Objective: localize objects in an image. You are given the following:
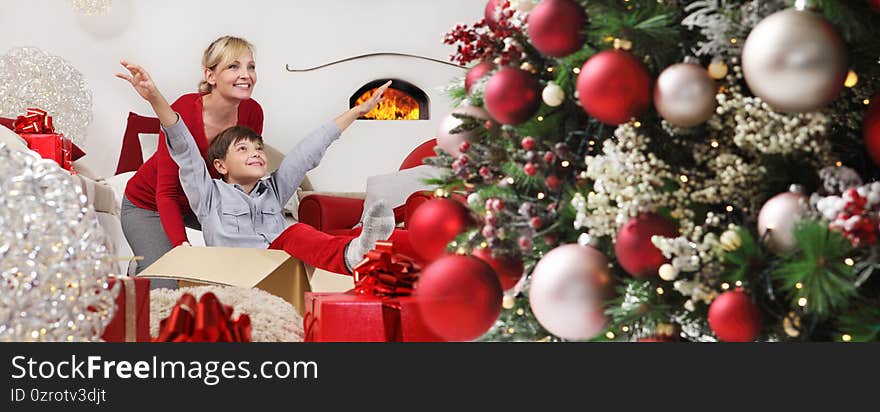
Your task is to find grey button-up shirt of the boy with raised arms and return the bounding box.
[162,116,342,248]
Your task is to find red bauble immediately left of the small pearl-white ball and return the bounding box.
[483,67,541,124]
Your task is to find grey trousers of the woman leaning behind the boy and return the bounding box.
[120,197,202,289]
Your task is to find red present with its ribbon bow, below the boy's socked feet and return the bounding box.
[303,242,444,342]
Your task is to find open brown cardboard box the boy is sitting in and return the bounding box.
[138,246,311,314]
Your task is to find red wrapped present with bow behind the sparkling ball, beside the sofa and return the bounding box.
[13,108,85,171]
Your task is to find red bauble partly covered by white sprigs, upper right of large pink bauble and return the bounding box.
[614,213,679,279]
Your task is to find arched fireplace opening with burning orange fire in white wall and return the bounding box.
[348,79,431,120]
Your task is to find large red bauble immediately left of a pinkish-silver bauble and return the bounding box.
[576,50,651,125]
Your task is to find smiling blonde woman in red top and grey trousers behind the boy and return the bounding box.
[121,36,263,288]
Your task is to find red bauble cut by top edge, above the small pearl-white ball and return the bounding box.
[528,0,586,57]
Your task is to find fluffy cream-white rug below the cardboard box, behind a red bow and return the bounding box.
[150,286,303,342]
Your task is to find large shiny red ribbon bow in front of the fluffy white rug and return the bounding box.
[153,292,251,342]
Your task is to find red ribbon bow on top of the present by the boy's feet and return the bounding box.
[354,241,421,297]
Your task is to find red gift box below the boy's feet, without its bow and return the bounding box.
[303,291,445,342]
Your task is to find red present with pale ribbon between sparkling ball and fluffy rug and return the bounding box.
[101,276,150,342]
